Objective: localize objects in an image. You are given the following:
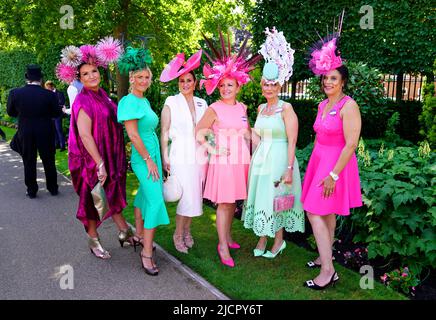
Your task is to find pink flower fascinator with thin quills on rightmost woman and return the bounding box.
[309,11,344,75]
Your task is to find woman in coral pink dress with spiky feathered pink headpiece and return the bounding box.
[196,34,261,267]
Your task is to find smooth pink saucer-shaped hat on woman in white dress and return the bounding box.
[159,49,203,82]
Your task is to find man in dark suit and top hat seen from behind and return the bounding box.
[7,65,62,199]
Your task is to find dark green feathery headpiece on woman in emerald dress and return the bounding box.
[117,46,153,75]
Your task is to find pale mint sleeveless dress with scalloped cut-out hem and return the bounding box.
[242,100,304,238]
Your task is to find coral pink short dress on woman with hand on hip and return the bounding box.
[203,101,250,203]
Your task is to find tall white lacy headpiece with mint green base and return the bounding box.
[259,27,295,86]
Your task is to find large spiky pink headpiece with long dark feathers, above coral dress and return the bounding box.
[200,31,262,95]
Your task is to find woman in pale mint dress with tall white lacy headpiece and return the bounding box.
[242,29,304,258]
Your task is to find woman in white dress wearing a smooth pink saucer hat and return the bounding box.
[160,50,207,253]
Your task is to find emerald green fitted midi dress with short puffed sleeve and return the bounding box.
[117,93,170,229]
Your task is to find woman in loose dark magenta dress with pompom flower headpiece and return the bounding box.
[57,38,133,259]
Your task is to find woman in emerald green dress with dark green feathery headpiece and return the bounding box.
[118,47,170,276]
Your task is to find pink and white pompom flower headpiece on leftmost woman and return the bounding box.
[56,36,123,84]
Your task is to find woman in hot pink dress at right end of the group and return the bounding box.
[301,15,362,290]
